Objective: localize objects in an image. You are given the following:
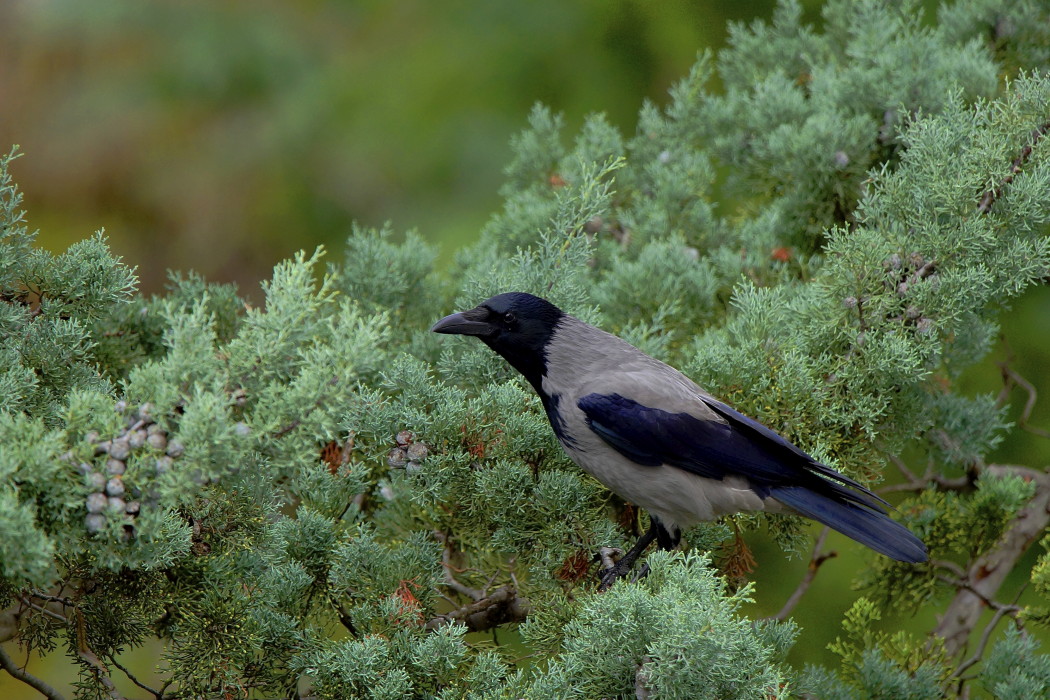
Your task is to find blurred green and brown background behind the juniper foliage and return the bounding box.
[0,0,1050,700]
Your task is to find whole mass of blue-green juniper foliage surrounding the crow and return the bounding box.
[0,0,1050,700]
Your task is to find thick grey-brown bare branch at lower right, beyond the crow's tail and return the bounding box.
[932,465,1050,655]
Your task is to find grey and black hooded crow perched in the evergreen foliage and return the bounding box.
[431,292,928,590]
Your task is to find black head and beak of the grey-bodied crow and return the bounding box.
[431,292,565,393]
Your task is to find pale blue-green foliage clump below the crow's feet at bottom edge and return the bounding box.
[522,552,794,700]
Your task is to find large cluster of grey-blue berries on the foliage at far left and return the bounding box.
[66,401,185,538]
